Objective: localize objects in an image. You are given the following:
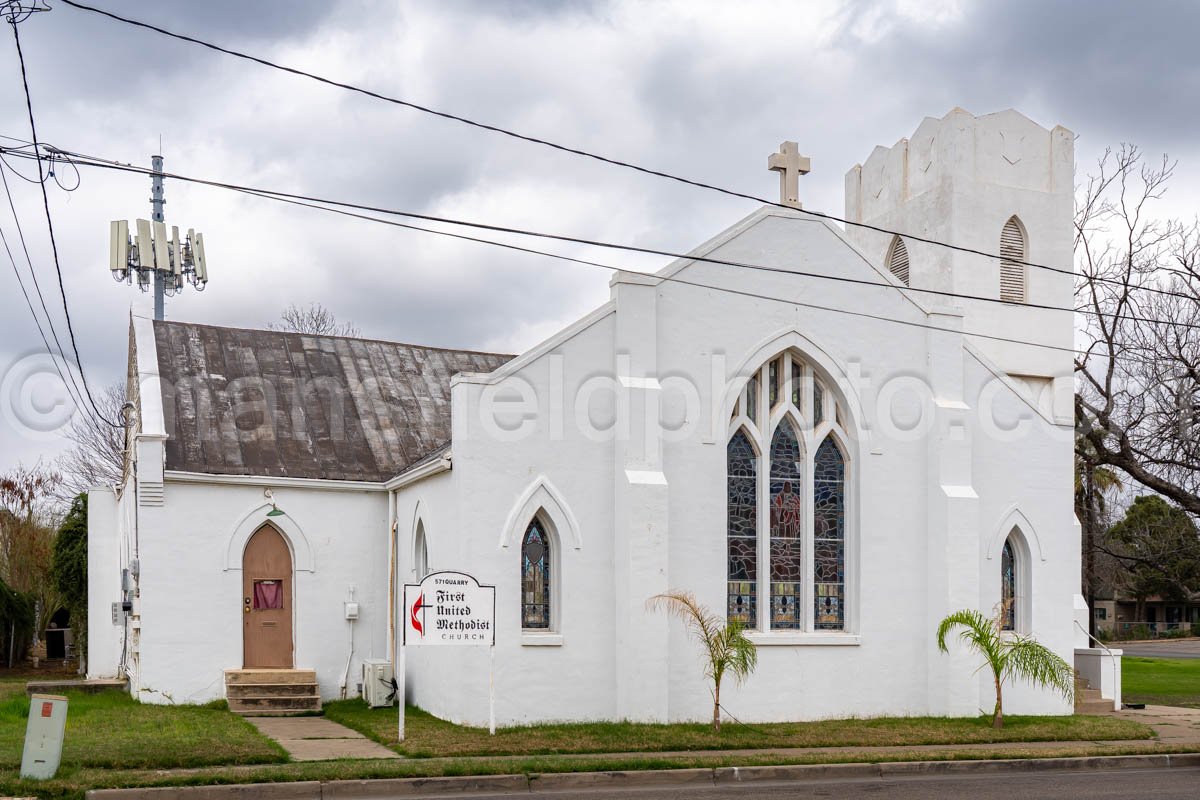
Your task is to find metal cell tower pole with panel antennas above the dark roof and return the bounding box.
[108,155,209,319]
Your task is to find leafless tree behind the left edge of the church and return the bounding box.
[56,383,126,505]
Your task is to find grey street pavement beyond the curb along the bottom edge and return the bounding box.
[391,768,1200,800]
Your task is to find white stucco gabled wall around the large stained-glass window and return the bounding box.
[406,200,1079,724]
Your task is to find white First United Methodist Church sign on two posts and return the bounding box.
[397,571,496,741]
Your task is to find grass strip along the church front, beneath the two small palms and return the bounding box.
[325,700,1152,758]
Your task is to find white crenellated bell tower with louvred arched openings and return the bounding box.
[846,108,1074,419]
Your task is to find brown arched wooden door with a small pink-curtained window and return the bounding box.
[241,525,294,669]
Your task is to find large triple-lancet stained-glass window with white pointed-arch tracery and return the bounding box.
[726,351,850,632]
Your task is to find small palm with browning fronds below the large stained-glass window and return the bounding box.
[646,591,758,733]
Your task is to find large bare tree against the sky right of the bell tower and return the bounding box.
[1075,145,1200,515]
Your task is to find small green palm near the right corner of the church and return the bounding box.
[937,607,1075,728]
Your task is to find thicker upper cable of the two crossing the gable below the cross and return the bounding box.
[11,146,1200,329]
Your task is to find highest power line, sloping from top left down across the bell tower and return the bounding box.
[62,0,1128,291]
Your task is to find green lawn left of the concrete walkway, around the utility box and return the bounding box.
[0,678,287,772]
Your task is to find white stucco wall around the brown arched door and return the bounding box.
[133,474,389,703]
